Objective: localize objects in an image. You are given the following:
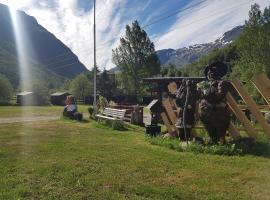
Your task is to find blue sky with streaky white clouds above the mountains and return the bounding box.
[0,0,270,70]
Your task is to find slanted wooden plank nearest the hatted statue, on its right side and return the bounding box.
[226,92,257,138]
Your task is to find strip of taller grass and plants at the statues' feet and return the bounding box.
[146,136,270,158]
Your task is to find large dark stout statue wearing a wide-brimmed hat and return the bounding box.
[198,62,231,143]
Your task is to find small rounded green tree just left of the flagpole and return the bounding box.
[70,74,94,99]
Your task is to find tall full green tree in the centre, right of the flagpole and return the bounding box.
[112,21,160,97]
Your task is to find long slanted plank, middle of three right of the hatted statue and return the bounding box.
[231,80,270,136]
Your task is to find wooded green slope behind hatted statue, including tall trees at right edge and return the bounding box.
[180,4,270,95]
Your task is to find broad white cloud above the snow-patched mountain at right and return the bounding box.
[154,0,270,49]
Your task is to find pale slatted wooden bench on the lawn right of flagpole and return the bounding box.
[96,108,126,121]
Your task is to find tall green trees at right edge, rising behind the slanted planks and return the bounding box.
[231,4,270,98]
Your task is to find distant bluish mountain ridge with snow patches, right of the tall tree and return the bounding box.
[157,26,244,68]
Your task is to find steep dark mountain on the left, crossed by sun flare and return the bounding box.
[0,4,87,85]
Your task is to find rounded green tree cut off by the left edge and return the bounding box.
[0,74,13,104]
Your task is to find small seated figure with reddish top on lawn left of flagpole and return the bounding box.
[63,95,82,121]
